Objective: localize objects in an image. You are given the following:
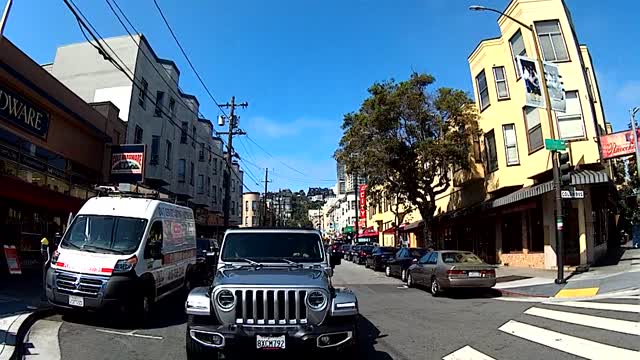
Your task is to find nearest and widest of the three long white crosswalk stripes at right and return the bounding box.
[499,320,640,360]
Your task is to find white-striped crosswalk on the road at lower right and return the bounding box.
[443,296,640,360]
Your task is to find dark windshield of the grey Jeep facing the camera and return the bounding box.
[222,232,324,263]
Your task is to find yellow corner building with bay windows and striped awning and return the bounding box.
[434,0,615,268]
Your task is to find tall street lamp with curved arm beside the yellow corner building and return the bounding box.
[469,5,566,284]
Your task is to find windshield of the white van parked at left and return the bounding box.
[60,215,147,255]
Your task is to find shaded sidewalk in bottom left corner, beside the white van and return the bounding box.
[0,271,49,360]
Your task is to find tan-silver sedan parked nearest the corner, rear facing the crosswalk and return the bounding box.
[407,250,496,296]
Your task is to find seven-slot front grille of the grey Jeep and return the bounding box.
[234,289,308,325]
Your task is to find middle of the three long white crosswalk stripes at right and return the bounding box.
[524,307,640,336]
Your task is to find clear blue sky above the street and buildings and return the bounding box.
[1,0,640,190]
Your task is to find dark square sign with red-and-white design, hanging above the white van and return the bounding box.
[111,144,146,183]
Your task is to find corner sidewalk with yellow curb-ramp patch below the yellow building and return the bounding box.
[495,249,640,298]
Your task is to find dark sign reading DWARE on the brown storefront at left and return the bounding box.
[0,87,49,139]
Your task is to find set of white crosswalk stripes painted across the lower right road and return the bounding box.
[443,297,640,360]
